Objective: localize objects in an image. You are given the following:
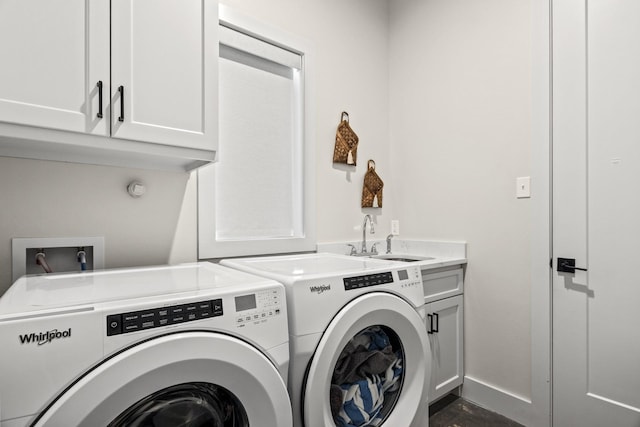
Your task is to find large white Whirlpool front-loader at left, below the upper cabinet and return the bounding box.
[0,263,292,427]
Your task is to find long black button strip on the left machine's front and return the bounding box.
[107,298,223,336]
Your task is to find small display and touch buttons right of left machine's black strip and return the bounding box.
[234,289,283,327]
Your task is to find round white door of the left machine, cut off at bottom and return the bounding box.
[33,332,293,427]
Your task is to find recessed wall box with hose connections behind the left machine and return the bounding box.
[11,237,104,282]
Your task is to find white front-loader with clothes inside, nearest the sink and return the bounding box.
[221,254,431,427]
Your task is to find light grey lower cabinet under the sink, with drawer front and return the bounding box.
[422,268,464,403]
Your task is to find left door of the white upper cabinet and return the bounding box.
[0,0,109,135]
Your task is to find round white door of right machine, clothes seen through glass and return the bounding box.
[303,292,431,427]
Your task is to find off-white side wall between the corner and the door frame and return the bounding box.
[390,0,535,412]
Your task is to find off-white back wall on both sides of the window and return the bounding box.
[0,0,394,294]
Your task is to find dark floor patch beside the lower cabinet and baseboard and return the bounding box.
[429,394,523,427]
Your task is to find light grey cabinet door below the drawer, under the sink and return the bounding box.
[427,295,464,402]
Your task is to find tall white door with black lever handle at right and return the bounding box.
[553,0,640,427]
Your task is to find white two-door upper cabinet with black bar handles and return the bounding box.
[0,0,218,170]
